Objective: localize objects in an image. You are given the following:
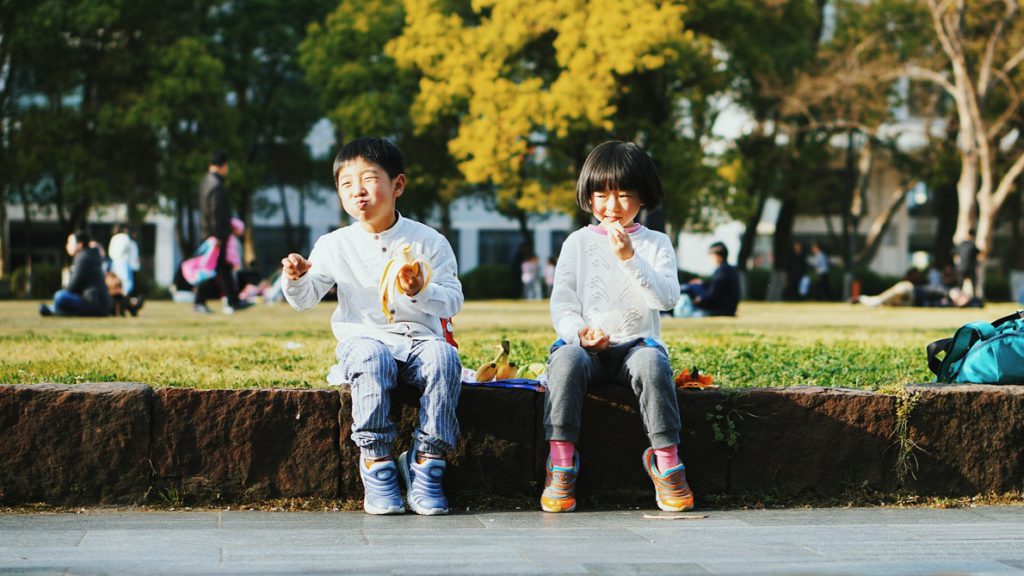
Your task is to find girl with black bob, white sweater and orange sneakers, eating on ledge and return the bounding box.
[541,141,693,512]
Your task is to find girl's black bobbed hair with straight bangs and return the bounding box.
[577,140,665,212]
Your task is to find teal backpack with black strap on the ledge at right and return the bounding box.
[928,310,1024,384]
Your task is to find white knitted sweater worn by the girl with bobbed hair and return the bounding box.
[551,227,679,346]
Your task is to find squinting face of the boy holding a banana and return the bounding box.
[337,158,406,232]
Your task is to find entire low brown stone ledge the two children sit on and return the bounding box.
[0,383,1024,504]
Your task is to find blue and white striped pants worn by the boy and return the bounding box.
[335,338,462,458]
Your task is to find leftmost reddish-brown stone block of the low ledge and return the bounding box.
[0,383,153,505]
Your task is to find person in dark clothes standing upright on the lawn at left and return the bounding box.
[193,152,248,314]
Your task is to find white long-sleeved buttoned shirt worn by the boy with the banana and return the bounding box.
[284,214,463,373]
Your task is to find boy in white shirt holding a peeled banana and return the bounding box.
[282,137,463,516]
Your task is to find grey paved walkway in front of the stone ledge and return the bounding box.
[0,506,1024,576]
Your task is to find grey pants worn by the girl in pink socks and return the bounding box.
[544,340,679,448]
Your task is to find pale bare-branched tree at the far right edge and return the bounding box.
[900,0,1024,290]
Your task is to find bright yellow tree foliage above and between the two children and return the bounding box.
[386,0,690,211]
